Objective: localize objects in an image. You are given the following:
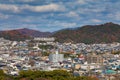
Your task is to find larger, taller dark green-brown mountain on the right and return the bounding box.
[53,22,120,44]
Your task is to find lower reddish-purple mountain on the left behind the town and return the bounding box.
[0,28,52,41]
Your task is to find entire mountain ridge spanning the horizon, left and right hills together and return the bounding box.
[0,22,120,44]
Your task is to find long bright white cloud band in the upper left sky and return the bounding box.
[0,4,65,13]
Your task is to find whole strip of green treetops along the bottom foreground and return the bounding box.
[0,70,97,80]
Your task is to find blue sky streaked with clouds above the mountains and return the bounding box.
[0,0,120,32]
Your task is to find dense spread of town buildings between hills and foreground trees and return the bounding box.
[0,38,120,80]
